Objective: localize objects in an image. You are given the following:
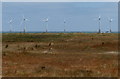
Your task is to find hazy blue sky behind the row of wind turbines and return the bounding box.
[2,2,118,31]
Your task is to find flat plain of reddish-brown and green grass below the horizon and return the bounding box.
[2,33,118,77]
